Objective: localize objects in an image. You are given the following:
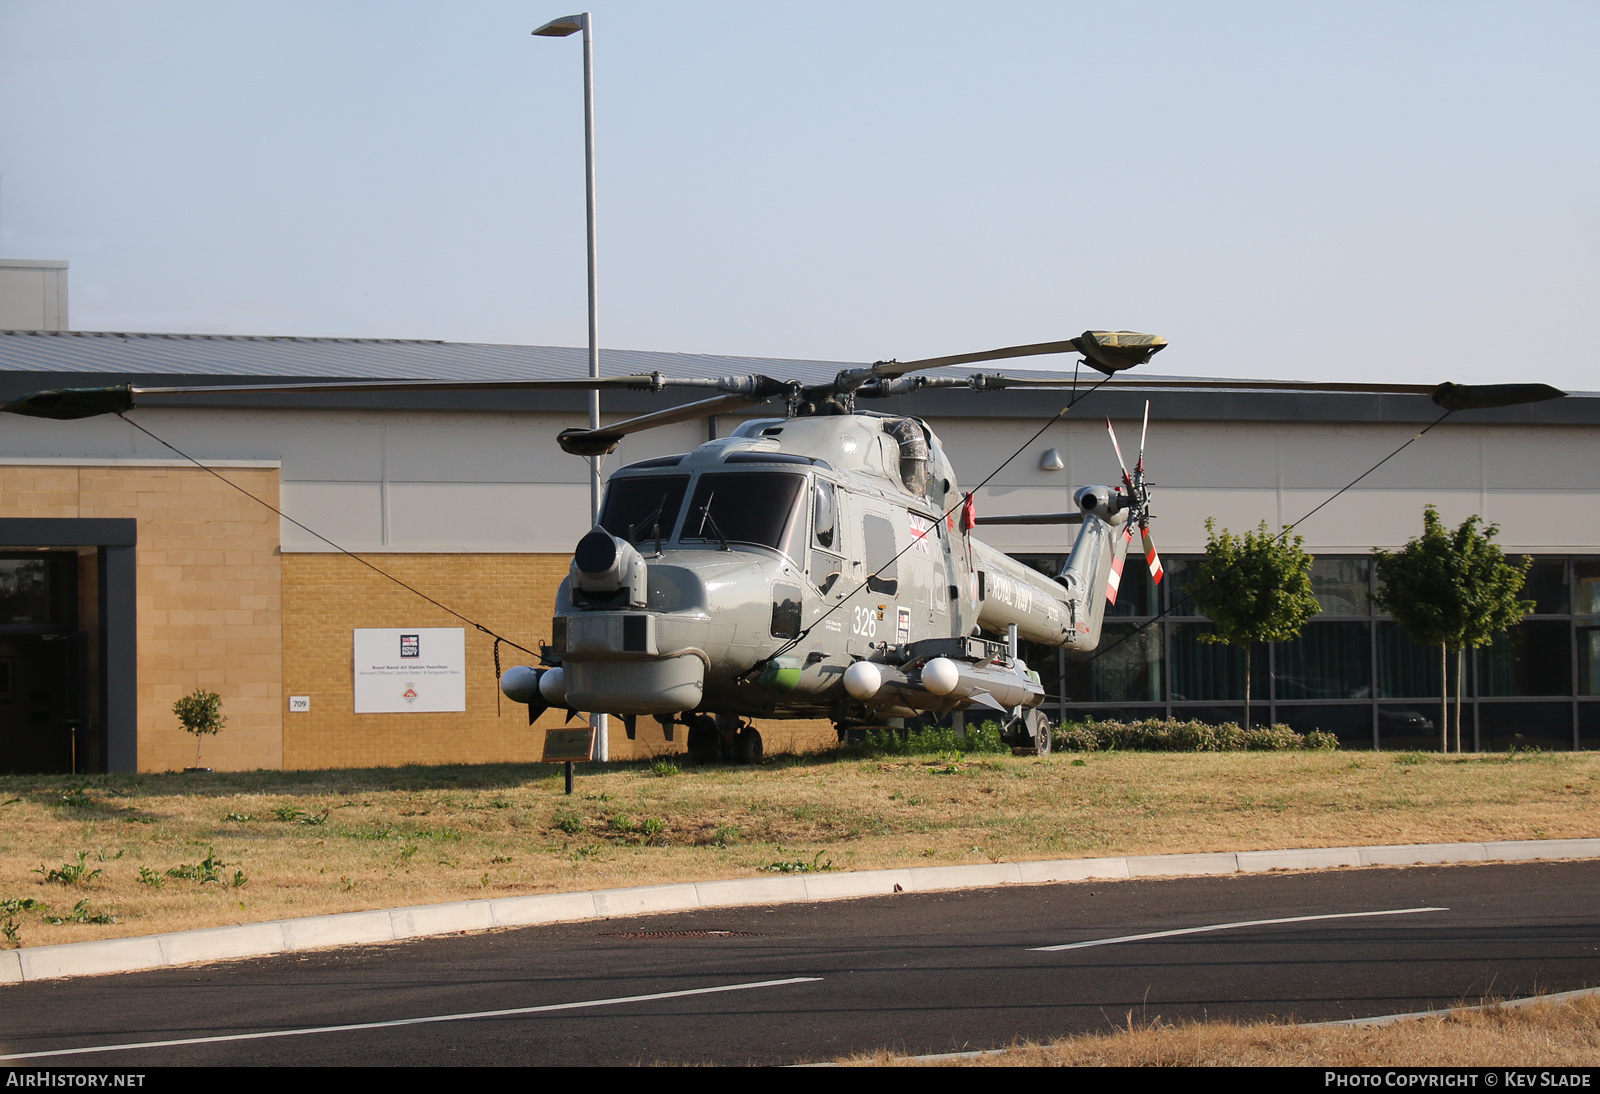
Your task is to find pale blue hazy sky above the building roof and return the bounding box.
[0,0,1600,390]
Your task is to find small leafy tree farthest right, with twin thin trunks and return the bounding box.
[1373,505,1533,752]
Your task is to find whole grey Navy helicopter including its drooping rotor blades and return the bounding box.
[0,331,1563,763]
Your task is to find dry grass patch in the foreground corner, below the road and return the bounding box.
[840,995,1600,1068]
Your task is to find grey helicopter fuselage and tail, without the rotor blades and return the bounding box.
[541,413,1126,728]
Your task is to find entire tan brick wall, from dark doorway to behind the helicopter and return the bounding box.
[0,465,834,771]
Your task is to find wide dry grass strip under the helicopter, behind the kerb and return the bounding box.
[0,752,1600,945]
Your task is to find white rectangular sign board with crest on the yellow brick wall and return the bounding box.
[355,627,467,713]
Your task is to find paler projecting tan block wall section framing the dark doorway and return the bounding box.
[0,465,283,771]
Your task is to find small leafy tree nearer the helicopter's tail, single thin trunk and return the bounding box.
[1189,517,1320,729]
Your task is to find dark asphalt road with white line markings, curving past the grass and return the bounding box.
[0,862,1600,1070]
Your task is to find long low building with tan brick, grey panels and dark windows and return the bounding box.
[0,324,1600,771]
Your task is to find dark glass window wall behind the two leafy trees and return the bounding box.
[1018,555,1600,750]
